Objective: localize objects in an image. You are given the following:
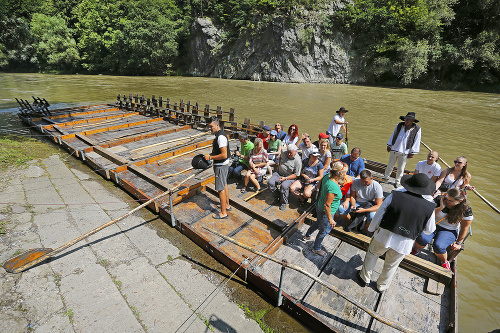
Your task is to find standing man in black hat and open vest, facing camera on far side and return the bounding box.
[384,112,422,187]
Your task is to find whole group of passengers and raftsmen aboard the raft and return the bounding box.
[205,108,473,291]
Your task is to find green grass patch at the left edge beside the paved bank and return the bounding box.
[0,134,56,170]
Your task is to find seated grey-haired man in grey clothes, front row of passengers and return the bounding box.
[267,144,302,210]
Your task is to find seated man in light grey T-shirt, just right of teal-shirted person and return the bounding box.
[339,170,384,234]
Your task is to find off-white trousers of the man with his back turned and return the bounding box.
[360,238,405,291]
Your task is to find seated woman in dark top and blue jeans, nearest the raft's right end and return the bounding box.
[411,188,474,269]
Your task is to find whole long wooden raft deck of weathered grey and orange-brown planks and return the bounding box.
[20,94,457,332]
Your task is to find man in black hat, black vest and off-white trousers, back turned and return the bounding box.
[357,173,436,292]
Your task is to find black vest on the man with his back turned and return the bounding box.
[380,191,436,239]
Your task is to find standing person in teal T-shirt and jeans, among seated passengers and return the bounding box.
[302,162,343,256]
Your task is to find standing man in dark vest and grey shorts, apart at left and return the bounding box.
[204,117,231,219]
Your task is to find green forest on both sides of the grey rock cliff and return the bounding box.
[0,0,500,89]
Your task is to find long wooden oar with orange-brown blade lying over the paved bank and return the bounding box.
[3,170,205,273]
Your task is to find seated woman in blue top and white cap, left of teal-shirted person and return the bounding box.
[290,150,323,206]
